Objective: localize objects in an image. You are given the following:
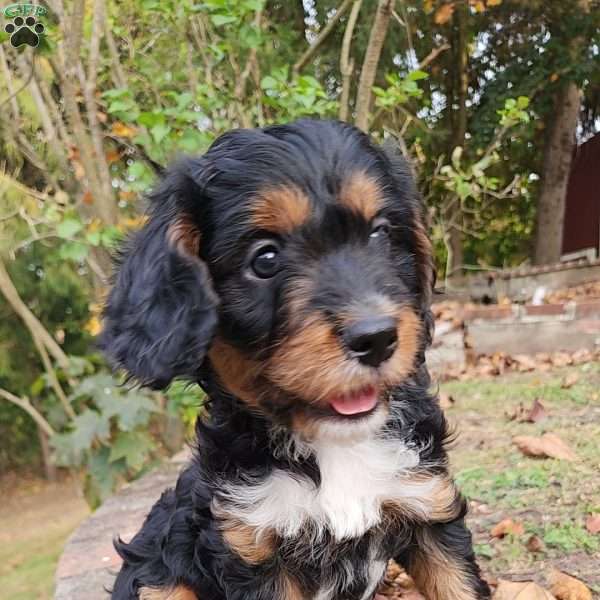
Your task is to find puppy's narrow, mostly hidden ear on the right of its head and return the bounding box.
[382,138,435,312]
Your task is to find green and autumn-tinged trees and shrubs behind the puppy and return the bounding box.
[0,0,600,504]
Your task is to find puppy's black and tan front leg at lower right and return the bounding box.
[399,517,490,600]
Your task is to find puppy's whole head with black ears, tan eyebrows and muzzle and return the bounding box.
[102,120,433,437]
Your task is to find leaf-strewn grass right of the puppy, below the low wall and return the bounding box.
[442,363,600,594]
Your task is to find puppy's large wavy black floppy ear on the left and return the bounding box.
[100,161,218,388]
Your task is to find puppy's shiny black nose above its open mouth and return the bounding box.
[343,317,398,367]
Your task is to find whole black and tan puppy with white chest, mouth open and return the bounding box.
[103,120,488,600]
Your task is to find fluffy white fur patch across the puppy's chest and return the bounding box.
[218,438,437,540]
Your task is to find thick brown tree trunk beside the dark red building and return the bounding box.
[533,81,581,265]
